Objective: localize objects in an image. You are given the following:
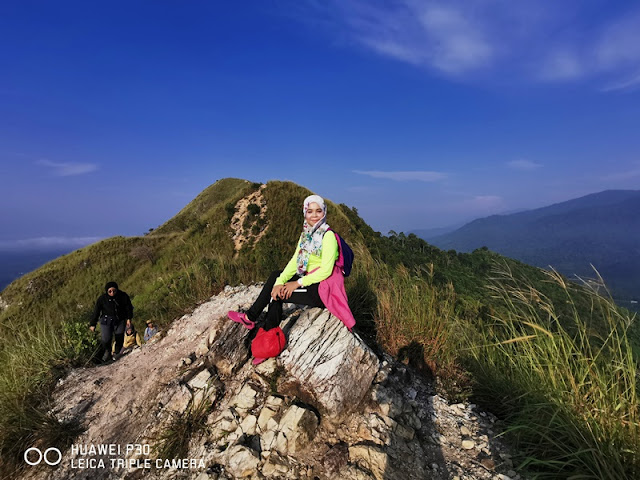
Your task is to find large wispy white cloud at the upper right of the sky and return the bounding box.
[305,0,640,91]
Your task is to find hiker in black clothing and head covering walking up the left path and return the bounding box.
[89,282,133,361]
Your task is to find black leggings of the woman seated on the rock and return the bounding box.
[247,271,324,330]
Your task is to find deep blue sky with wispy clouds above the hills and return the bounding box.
[0,0,640,247]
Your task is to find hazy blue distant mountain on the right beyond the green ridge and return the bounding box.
[424,190,640,303]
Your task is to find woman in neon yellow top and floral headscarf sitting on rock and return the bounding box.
[228,195,356,364]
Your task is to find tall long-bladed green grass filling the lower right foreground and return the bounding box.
[466,264,640,480]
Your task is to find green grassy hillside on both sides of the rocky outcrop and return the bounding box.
[0,179,640,478]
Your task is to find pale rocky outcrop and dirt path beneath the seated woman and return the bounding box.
[24,286,517,480]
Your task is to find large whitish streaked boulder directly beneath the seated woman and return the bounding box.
[280,308,379,419]
